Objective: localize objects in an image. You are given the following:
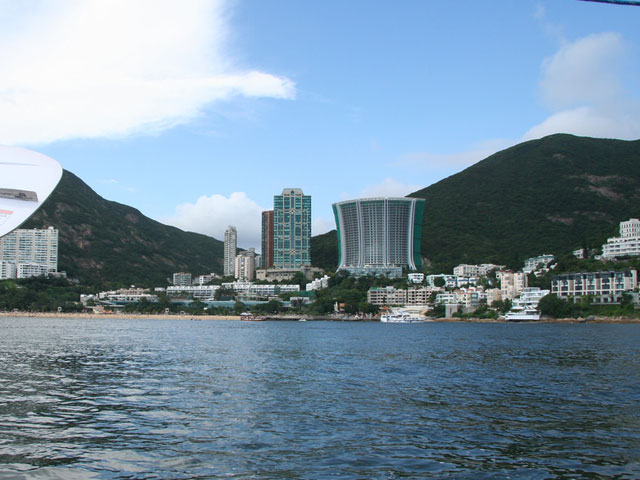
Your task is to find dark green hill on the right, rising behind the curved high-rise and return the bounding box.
[312,134,640,272]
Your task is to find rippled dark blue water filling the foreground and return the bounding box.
[0,318,640,479]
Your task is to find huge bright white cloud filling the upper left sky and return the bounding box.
[0,0,295,144]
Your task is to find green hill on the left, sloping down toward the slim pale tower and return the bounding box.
[22,171,223,286]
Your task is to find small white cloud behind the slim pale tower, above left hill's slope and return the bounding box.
[165,192,266,251]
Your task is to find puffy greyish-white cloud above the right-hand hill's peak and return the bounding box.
[524,33,640,140]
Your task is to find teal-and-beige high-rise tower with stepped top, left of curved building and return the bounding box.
[273,188,311,268]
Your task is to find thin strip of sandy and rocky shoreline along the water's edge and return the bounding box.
[0,312,640,324]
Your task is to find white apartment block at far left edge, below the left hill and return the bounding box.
[0,227,58,278]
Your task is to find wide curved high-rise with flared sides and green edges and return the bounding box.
[333,198,424,275]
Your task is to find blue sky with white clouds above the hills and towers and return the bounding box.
[0,0,640,251]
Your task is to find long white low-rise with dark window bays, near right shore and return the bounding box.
[551,270,638,303]
